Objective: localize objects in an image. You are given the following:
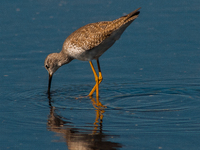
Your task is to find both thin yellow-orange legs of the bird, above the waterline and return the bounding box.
[88,59,103,97]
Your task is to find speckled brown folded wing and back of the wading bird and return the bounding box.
[65,8,140,50]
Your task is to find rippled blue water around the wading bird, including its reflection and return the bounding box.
[0,0,200,150]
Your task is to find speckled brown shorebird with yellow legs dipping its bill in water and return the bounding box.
[44,8,140,97]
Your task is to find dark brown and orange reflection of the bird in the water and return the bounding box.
[47,96,122,150]
